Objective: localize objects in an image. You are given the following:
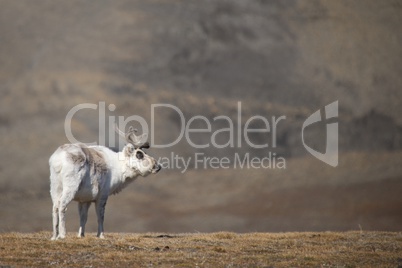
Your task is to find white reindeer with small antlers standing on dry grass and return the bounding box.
[49,127,161,240]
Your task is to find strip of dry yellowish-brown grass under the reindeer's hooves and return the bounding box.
[0,232,402,267]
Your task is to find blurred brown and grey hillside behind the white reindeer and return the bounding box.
[0,0,402,232]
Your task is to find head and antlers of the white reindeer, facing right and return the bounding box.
[115,125,162,177]
